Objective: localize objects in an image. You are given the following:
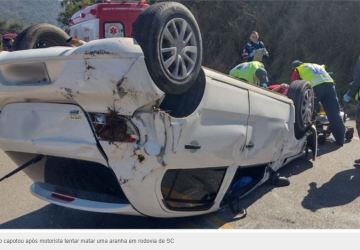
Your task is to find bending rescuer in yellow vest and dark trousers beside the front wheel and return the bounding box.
[291,60,345,146]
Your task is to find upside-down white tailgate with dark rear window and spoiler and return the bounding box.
[0,103,146,215]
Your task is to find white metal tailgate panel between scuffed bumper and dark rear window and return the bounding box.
[0,103,106,164]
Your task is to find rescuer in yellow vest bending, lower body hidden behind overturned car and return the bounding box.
[229,61,269,88]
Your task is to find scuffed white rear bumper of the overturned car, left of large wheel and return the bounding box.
[0,38,164,115]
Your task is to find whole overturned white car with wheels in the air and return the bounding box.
[0,2,316,217]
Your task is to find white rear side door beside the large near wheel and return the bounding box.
[169,77,249,168]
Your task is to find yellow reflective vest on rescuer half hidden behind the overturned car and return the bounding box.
[230,61,265,85]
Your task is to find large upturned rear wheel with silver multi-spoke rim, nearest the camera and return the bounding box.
[133,2,203,94]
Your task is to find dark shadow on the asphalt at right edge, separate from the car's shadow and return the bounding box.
[302,168,360,212]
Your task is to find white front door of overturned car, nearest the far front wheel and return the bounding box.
[242,90,293,166]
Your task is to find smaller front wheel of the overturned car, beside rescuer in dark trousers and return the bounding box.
[287,81,314,139]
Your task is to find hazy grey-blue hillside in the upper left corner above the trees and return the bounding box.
[0,0,61,27]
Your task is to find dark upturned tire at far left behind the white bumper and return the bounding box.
[13,24,71,51]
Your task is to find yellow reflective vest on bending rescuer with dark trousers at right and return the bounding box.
[296,63,334,87]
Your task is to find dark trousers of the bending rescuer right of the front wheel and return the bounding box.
[314,83,346,146]
